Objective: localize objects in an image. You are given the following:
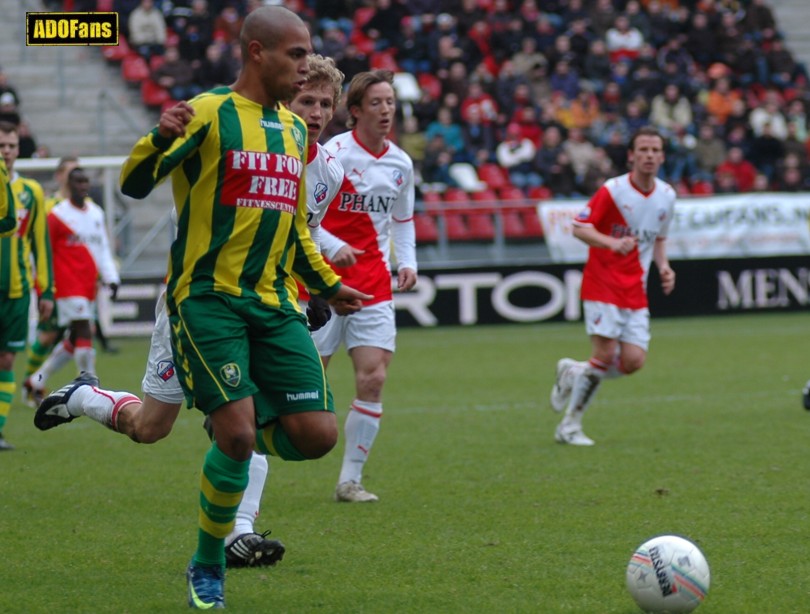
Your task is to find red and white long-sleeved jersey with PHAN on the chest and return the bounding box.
[322,132,417,303]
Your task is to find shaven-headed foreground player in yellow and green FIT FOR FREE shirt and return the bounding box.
[121,6,370,609]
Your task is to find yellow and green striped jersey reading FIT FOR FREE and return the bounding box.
[121,87,340,310]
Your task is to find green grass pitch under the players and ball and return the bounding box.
[0,313,810,614]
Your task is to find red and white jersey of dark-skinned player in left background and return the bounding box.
[48,199,121,301]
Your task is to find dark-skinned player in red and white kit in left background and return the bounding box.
[26,167,121,394]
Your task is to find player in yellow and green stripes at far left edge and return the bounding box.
[0,122,54,450]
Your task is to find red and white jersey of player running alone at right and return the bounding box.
[573,173,676,309]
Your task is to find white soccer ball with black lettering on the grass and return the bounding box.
[627,535,710,614]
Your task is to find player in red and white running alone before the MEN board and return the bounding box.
[551,127,675,446]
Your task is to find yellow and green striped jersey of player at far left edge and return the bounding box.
[0,173,54,300]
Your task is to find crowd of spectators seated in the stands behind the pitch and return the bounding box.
[79,0,810,198]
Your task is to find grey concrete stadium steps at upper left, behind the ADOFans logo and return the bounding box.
[0,0,171,276]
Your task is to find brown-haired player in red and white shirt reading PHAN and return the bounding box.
[313,70,417,502]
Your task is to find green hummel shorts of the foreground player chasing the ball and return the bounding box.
[169,294,335,427]
